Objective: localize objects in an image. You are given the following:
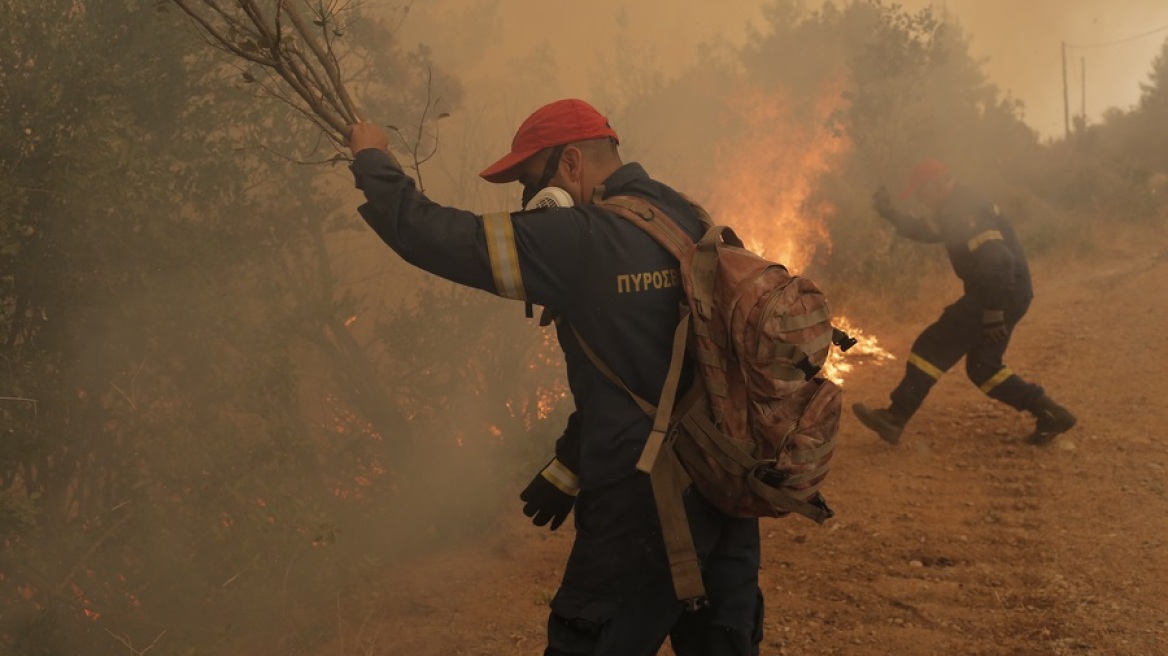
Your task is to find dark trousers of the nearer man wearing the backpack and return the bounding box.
[544,473,763,656]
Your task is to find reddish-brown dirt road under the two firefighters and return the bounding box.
[315,226,1168,656]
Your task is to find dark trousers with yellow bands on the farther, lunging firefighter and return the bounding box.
[891,295,1043,419]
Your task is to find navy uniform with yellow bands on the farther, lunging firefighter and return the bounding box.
[891,184,1043,419]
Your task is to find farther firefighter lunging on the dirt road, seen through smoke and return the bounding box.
[853,159,1075,446]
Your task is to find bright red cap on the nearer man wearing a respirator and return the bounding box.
[479,98,619,182]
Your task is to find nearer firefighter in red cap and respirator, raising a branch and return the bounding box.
[349,99,763,656]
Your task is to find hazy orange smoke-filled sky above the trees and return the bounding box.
[403,0,1168,137]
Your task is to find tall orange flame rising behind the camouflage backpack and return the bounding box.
[708,85,850,272]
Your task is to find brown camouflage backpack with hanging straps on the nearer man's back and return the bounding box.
[588,196,842,608]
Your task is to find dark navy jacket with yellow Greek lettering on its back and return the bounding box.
[352,149,701,489]
